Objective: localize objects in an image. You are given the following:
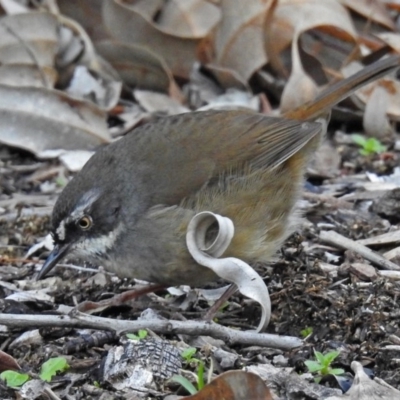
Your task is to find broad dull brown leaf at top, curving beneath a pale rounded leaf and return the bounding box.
[103,0,218,78]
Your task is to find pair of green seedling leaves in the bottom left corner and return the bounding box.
[0,357,69,387]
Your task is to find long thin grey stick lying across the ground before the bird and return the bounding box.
[0,312,303,350]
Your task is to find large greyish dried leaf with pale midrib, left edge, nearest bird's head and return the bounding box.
[0,85,110,155]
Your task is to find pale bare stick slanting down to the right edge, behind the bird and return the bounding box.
[319,231,400,271]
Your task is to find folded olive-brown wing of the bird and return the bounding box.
[118,111,326,204]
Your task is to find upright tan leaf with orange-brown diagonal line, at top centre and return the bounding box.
[215,0,272,81]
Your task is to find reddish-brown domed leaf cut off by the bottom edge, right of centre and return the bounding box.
[185,371,272,400]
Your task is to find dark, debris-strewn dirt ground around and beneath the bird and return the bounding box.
[0,137,400,399]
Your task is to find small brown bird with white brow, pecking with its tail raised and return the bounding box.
[39,56,399,286]
